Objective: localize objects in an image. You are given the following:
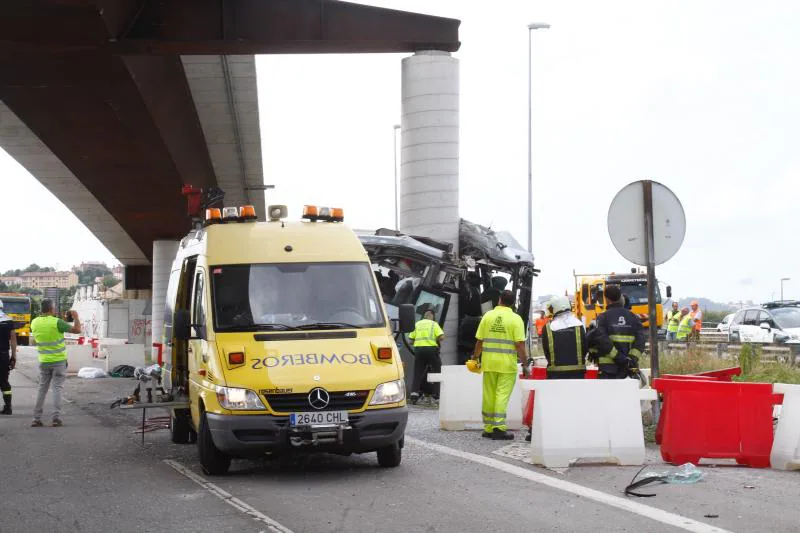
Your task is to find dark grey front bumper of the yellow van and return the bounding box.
[206,407,408,457]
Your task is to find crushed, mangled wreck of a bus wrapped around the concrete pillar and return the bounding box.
[357,220,539,376]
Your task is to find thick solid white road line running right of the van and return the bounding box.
[405,435,731,533]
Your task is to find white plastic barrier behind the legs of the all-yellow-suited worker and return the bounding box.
[428,365,522,431]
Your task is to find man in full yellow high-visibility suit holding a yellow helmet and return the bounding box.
[472,291,528,440]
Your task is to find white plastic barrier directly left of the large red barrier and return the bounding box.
[521,379,656,468]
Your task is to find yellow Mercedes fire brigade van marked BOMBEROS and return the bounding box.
[164,206,414,474]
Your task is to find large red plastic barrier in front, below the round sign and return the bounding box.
[653,378,780,468]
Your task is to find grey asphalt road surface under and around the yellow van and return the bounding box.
[0,349,800,533]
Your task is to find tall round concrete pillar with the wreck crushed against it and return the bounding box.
[399,50,460,364]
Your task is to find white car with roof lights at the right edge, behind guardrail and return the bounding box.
[728,302,800,344]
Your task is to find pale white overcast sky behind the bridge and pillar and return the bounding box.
[0,0,800,302]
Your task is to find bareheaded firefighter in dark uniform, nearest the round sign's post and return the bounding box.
[588,285,645,379]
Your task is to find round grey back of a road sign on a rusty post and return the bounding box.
[608,181,686,266]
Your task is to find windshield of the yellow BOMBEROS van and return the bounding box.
[211,263,386,331]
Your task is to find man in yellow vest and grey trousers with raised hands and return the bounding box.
[31,298,81,427]
